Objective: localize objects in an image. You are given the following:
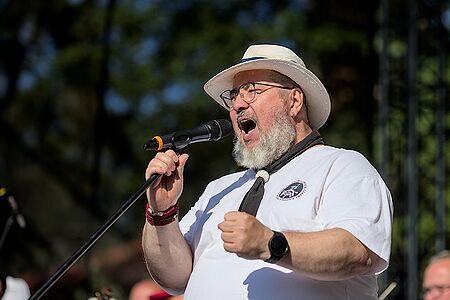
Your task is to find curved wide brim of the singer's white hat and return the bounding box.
[204,58,331,129]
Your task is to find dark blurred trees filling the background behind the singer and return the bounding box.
[0,0,450,299]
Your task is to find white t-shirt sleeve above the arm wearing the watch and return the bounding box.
[319,152,393,274]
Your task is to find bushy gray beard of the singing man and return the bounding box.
[233,112,296,170]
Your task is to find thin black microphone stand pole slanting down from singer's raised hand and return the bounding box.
[28,174,161,300]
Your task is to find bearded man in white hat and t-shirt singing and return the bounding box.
[142,45,393,300]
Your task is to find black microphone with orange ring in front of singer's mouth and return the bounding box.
[144,119,232,151]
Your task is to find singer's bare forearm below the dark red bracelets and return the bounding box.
[142,221,192,292]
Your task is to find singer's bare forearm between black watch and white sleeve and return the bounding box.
[278,228,377,280]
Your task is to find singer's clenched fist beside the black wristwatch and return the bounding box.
[218,211,273,260]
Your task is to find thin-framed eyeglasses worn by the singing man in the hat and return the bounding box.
[220,82,294,110]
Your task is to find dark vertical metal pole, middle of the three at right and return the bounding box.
[406,0,418,300]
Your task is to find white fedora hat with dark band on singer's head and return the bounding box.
[204,45,331,129]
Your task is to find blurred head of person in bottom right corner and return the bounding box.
[422,250,450,300]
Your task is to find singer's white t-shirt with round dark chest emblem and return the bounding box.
[180,146,393,300]
